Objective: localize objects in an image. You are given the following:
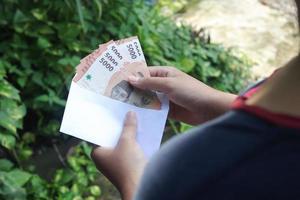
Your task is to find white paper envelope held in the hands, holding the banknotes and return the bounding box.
[60,81,169,157]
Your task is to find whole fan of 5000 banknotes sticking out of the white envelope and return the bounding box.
[73,36,161,110]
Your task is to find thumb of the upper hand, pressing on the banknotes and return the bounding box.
[128,76,171,93]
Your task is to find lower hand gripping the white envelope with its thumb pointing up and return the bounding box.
[91,112,147,200]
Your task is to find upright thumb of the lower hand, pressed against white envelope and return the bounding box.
[120,111,137,139]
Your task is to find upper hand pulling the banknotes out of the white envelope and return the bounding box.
[129,67,235,125]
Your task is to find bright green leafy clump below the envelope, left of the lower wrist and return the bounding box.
[51,142,101,200]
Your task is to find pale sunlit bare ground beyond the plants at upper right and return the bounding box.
[176,0,299,77]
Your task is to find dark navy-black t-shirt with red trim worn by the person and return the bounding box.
[135,110,300,200]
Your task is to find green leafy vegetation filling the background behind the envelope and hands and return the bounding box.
[0,0,250,200]
